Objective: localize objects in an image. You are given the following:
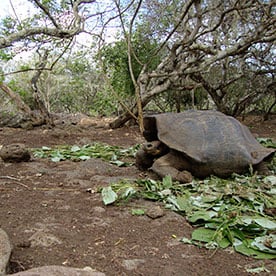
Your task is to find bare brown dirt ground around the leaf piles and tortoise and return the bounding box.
[0,117,276,276]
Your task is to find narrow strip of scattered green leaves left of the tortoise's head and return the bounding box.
[33,142,138,167]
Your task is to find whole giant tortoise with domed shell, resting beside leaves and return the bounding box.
[136,110,275,183]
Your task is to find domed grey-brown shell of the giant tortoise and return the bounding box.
[143,110,275,171]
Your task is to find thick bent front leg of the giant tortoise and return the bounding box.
[151,153,193,183]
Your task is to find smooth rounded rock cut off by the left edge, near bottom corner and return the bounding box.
[0,228,12,275]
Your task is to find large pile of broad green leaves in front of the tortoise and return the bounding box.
[102,175,276,259]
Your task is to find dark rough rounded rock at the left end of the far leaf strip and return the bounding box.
[0,144,31,163]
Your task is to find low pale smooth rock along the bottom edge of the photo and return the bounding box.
[12,265,105,276]
